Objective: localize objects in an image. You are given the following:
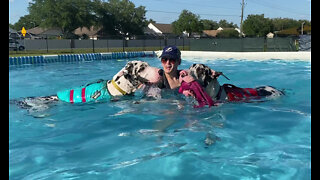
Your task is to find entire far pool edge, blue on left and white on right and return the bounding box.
[9,51,311,66]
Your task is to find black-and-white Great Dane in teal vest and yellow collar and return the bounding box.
[11,61,161,111]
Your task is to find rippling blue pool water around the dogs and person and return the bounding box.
[9,58,311,180]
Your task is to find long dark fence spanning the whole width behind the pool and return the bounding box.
[9,37,311,54]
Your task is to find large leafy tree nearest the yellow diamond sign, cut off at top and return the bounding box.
[28,0,94,37]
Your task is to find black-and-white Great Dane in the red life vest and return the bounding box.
[179,64,284,105]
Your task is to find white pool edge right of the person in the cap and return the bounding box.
[181,51,311,61]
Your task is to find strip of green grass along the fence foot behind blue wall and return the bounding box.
[9,46,190,57]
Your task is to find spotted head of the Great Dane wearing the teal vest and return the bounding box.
[113,61,161,94]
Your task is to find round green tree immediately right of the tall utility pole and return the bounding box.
[243,14,273,37]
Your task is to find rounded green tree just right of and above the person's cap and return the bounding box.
[172,10,203,36]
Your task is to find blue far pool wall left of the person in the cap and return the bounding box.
[9,51,155,66]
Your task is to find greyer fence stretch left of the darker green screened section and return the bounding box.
[11,37,190,53]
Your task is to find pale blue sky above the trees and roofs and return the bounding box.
[9,0,311,26]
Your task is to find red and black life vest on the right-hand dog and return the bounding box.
[222,84,260,101]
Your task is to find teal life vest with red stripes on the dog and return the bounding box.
[57,80,111,103]
